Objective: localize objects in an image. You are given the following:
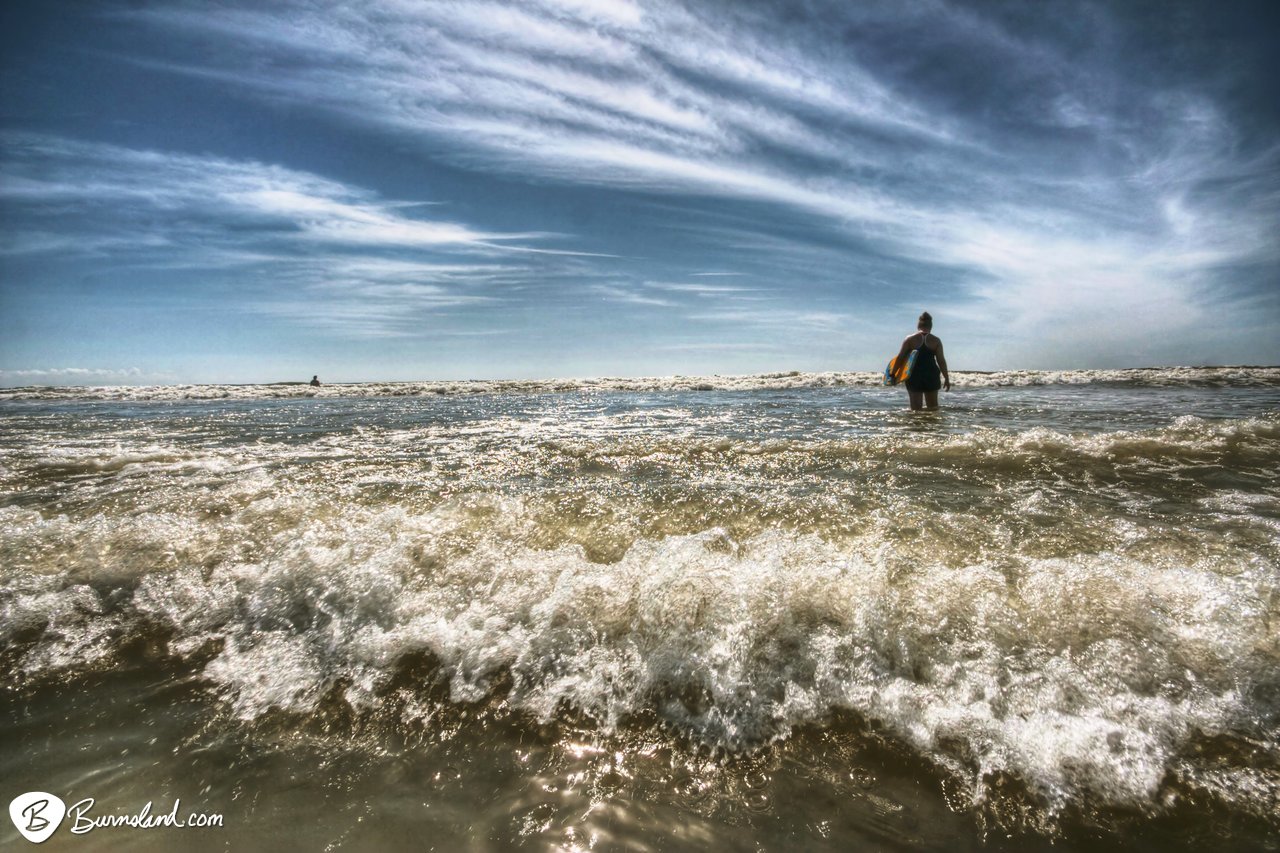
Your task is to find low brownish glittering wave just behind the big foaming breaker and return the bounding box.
[0,412,1280,535]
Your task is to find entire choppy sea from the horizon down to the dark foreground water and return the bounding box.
[0,368,1280,853]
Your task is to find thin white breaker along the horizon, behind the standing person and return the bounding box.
[0,366,1280,401]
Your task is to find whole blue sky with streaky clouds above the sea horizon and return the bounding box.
[0,0,1280,386]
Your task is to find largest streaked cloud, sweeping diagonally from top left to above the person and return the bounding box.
[115,0,1280,357]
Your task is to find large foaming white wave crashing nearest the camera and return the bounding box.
[0,496,1280,809]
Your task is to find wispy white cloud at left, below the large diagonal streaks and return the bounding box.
[0,133,588,337]
